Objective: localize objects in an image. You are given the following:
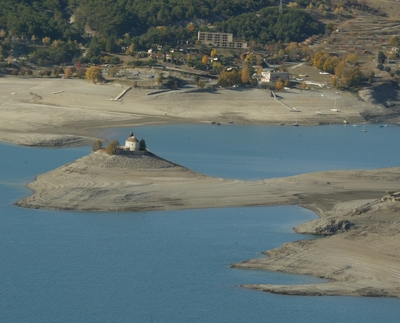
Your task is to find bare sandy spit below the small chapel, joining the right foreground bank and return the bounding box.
[16,151,400,297]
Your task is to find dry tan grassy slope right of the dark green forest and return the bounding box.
[306,0,400,81]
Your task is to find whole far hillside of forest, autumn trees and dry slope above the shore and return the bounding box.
[0,0,400,98]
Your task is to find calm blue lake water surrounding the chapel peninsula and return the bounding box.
[0,125,400,323]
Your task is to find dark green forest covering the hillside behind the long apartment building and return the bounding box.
[0,0,323,65]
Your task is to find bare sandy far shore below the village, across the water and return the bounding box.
[0,77,398,146]
